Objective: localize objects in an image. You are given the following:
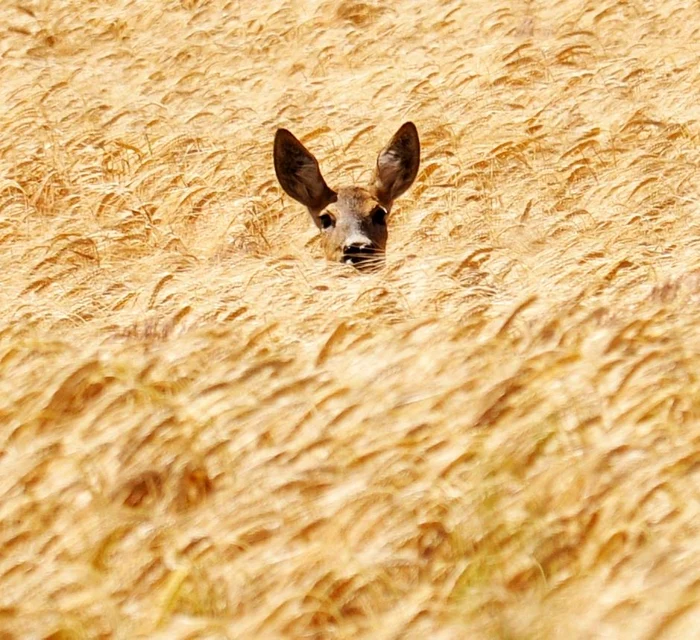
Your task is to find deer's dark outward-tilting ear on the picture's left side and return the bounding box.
[274,129,338,215]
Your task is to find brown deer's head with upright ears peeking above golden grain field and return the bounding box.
[273,122,420,270]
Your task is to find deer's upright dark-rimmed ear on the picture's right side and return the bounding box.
[374,122,420,209]
